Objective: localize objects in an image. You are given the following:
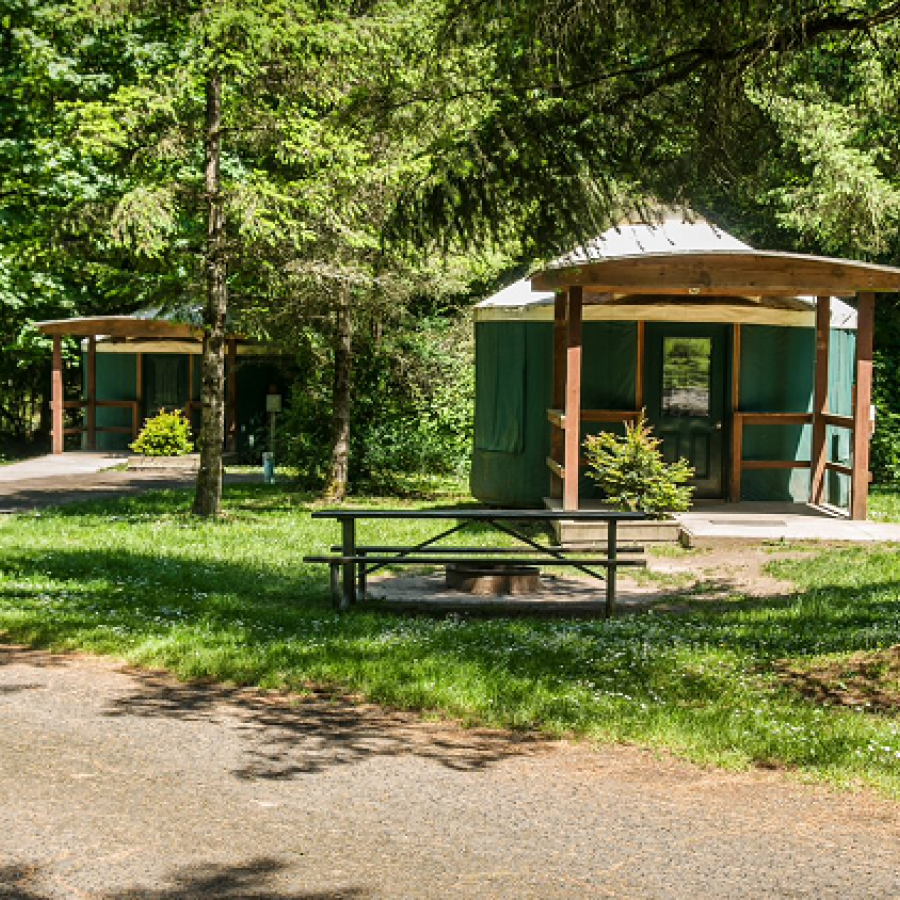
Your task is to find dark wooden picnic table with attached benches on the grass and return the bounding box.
[303,508,646,618]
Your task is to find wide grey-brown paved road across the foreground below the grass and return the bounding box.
[0,647,900,900]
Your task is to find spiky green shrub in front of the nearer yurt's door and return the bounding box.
[584,415,694,519]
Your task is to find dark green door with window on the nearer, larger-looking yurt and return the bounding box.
[645,322,728,497]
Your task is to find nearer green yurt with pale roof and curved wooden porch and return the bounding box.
[471,214,900,517]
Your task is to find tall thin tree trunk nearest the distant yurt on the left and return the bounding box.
[194,72,228,516]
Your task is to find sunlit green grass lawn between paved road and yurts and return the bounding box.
[0,485,900,796]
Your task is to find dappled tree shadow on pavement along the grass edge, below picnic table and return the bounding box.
[107,671,548,781]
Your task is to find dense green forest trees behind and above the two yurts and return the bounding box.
[0,0,900,506]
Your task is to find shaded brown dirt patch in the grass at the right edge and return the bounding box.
[776,644,900,715]
